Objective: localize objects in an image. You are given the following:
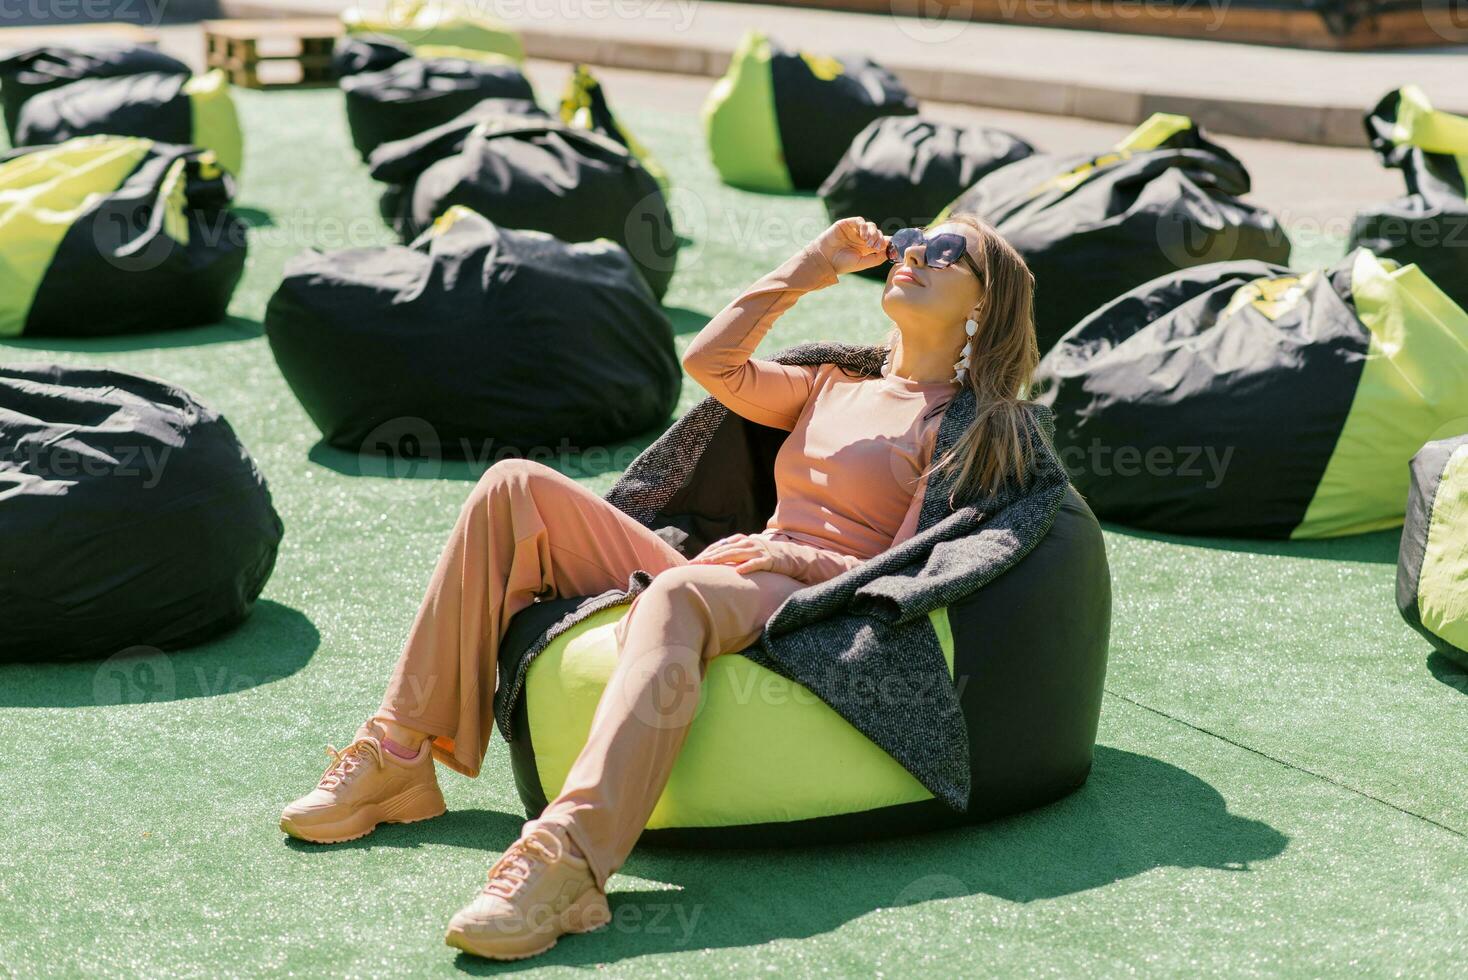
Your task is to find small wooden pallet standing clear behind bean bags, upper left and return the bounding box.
[200,18,342,88]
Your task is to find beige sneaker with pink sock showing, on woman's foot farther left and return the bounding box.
[280,722,446,844]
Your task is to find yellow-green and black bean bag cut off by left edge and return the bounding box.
[0,136,247,337]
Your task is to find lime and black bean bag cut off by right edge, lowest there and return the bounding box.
[1396,436,1468,668]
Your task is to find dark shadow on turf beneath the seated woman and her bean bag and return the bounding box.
[288,747,1289,974]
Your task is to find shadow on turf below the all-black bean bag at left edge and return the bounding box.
[0,600,321,707]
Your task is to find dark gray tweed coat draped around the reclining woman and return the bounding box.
[496,342,1069,811]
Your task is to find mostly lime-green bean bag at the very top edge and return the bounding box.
[342,0,526,62]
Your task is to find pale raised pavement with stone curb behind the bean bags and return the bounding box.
[214,0,1468,145]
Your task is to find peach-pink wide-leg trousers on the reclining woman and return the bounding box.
[377,459,803,889]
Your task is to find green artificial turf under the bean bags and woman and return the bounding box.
[0,91,1468,977]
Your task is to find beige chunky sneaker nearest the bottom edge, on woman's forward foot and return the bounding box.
[443,822,612,959]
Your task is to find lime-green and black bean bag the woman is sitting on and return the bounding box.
[496,481,1111,846]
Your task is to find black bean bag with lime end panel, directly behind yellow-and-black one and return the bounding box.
[12,69,245,179]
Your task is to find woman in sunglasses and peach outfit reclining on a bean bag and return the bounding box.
[280,214,1039,959]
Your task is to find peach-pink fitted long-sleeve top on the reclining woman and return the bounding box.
[683,242,959,582]
